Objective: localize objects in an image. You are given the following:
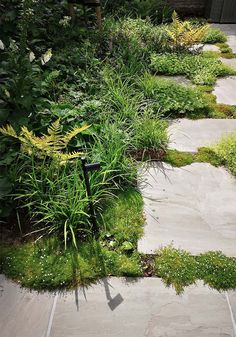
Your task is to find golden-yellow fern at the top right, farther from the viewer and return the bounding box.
[166,11,209,50]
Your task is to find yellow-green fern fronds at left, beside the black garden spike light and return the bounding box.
[0,120,89,164]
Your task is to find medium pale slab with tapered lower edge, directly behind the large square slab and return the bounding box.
[168,119,236,152]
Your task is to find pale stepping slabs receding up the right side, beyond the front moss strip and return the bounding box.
[138,25,236,257]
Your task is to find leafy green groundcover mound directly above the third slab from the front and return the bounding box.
[140,74,209,115]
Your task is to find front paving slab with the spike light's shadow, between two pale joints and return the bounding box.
[50,278,235,337]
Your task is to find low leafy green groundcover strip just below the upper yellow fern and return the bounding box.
[151,54,235,85]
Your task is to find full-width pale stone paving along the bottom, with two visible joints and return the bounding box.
[0,275,236,337]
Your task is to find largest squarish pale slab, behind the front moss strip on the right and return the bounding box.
[138,162,236,256]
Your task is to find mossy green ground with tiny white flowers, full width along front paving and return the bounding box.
[0,182,236,294]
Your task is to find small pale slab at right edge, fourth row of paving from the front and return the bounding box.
[215,76,236,105]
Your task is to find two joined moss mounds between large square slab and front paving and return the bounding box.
[155,245,236,294]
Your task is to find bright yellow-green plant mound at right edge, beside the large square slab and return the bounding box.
[213,134,236,174]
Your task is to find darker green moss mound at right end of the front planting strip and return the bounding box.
[197,252,236,290]
